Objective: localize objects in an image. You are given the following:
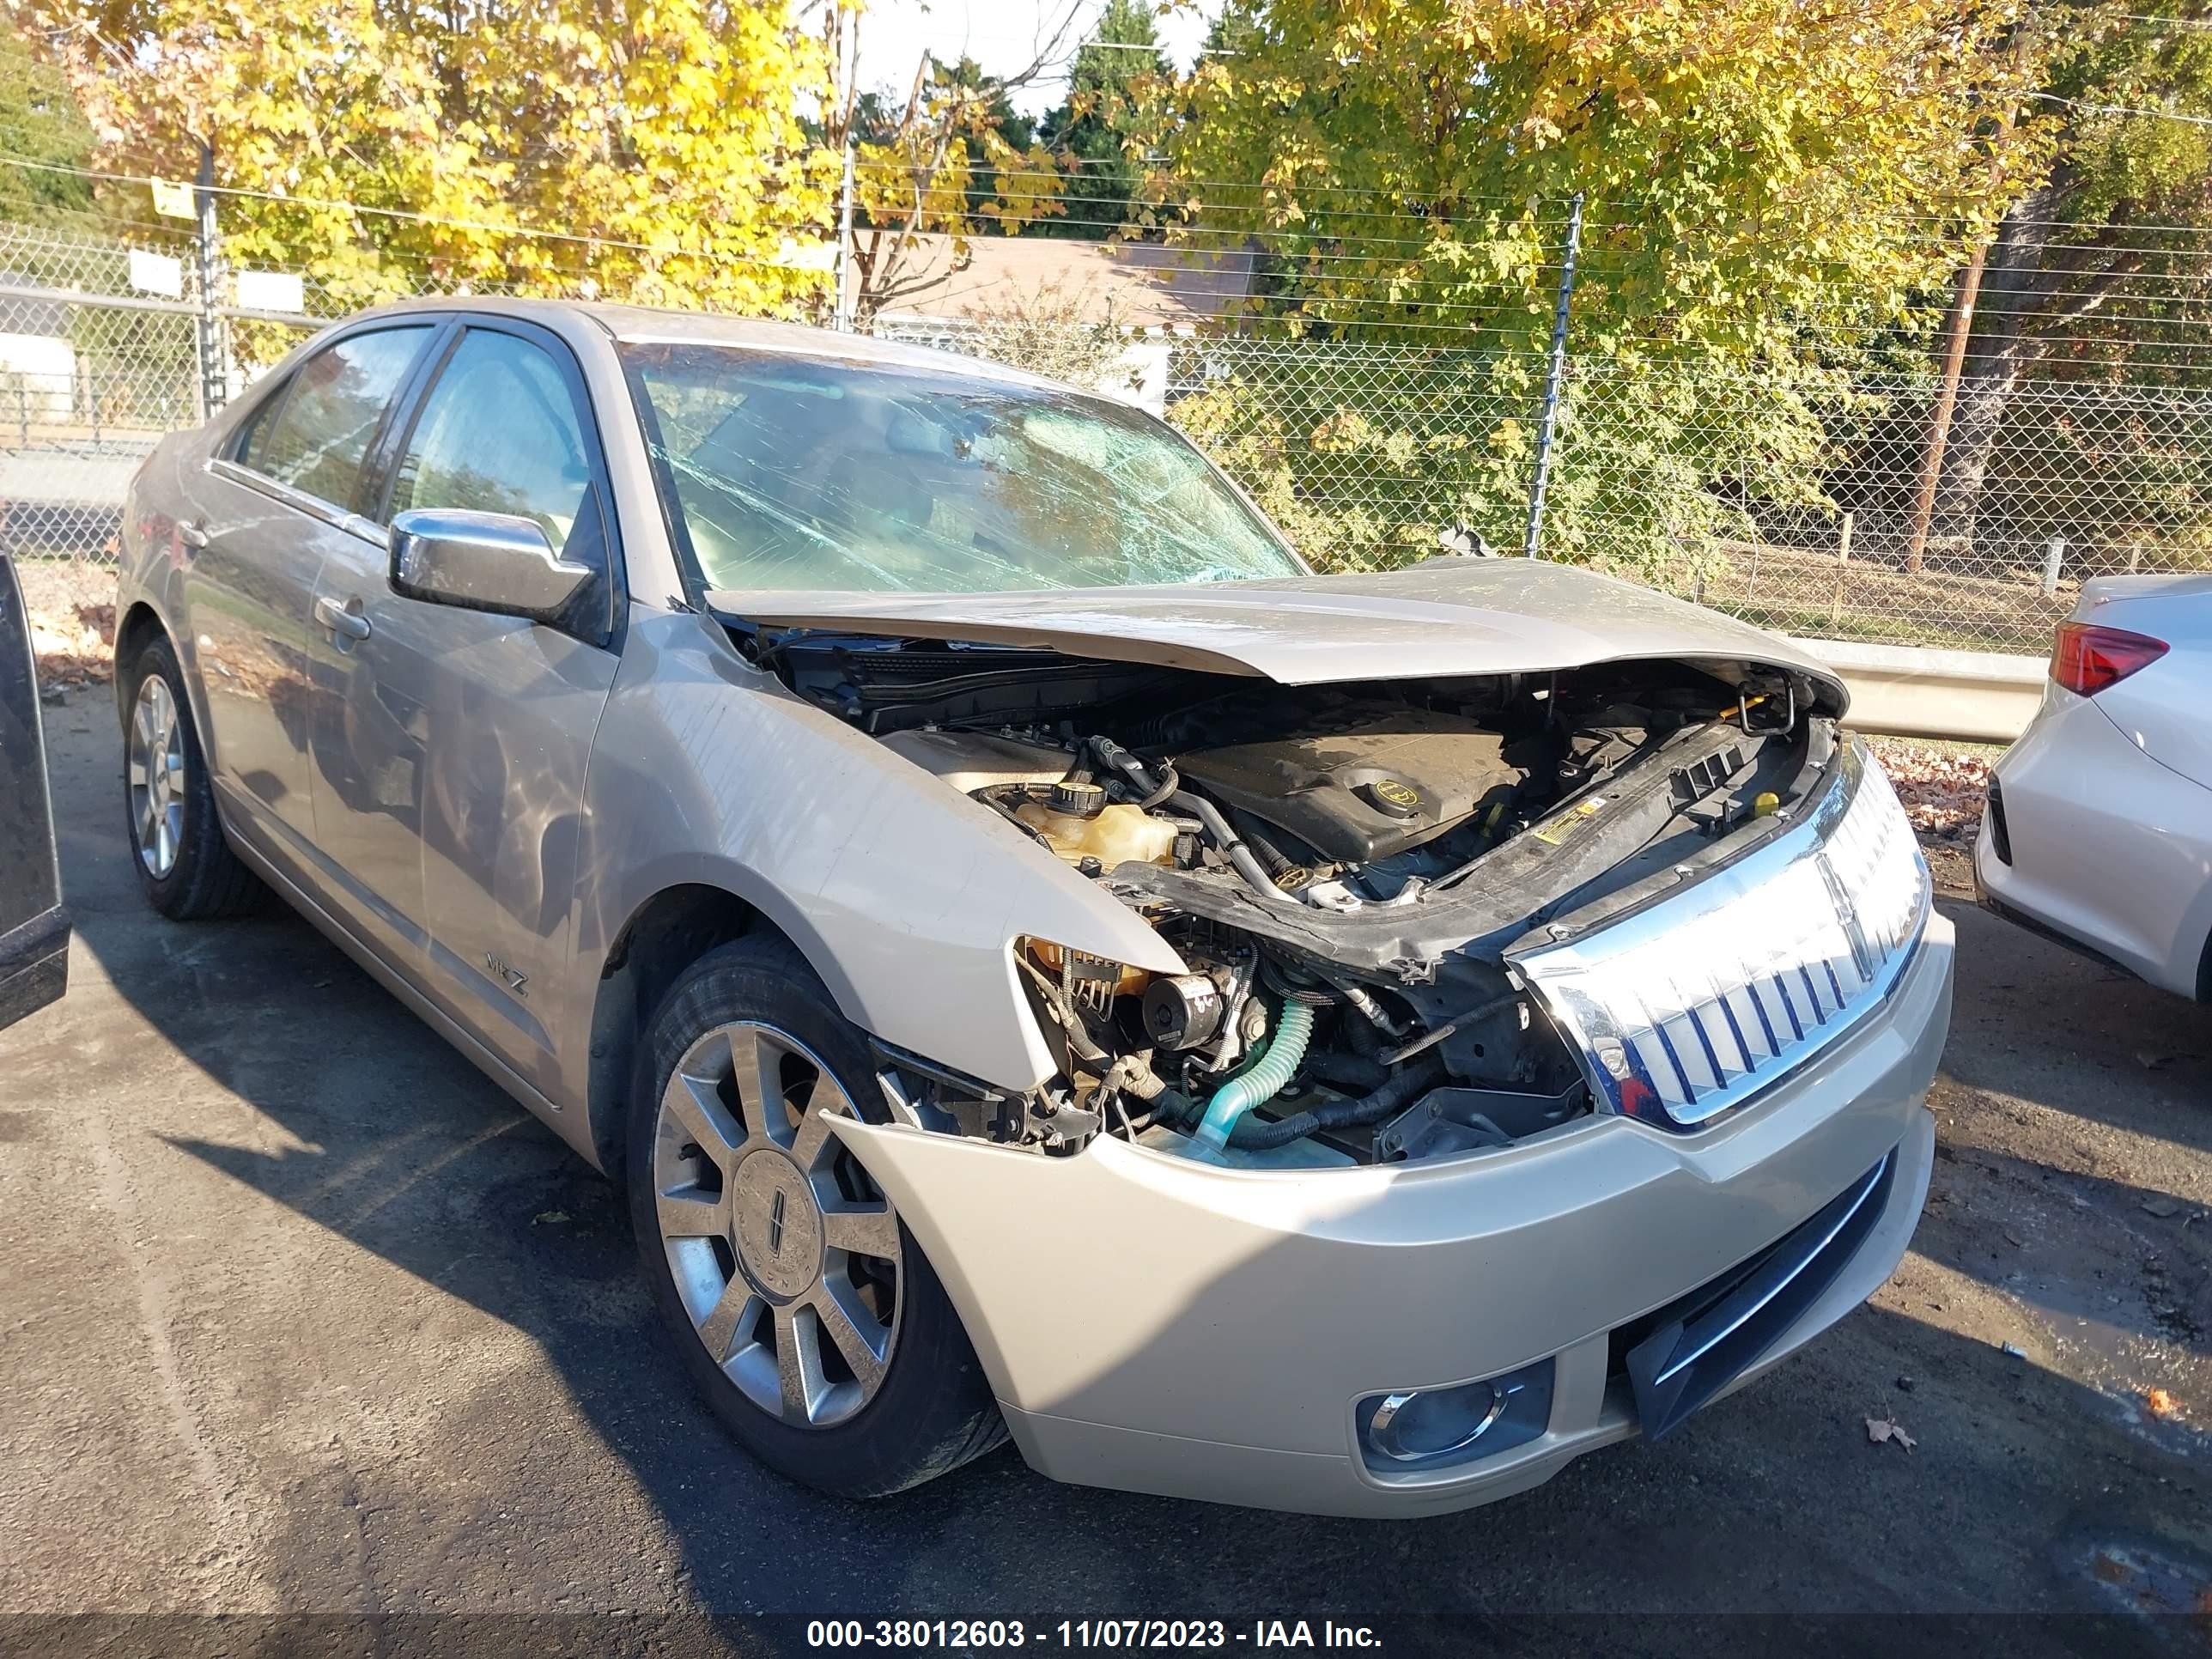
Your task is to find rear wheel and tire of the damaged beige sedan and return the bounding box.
[122,635,268,922]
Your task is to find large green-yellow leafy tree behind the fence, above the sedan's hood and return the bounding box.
[1146,0,2046,575]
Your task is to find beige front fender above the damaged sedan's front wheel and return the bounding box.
[566,606,1183,1106]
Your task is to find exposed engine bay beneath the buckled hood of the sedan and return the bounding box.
[741,630,1836,1168]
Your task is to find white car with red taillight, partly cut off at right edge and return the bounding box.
[1973,575,2212,1000]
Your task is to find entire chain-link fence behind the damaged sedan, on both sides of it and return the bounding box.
[0,223,2212,654]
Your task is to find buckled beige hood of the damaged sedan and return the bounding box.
[706,560,1847,712]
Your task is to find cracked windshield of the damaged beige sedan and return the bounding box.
[622,343,1303,592]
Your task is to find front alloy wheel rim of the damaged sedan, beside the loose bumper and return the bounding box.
[653,1020,900,1429]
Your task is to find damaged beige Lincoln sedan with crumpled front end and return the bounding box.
[118,301,1951,1516]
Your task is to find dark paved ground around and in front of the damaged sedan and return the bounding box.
[0,708,2212,1652]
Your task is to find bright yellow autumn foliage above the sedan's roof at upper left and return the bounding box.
[30,0,836,329]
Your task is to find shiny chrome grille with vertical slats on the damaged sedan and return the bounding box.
[1510,741,1931,1128]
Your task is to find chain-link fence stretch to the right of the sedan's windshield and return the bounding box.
[900,325,2212,654]
